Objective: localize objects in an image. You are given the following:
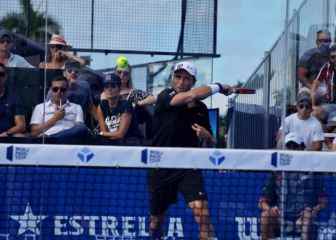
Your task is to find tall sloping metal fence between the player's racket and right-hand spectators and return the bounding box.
[228,0,336,149]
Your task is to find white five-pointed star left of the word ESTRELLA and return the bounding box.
[10,202,47,235]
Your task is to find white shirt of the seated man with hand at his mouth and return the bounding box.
[30,100,84,135]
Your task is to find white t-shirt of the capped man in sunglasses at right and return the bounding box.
[280,113,324,150]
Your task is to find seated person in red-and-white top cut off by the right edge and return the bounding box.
[311,45,336,122]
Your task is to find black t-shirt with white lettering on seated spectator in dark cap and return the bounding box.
[100,100,138,137]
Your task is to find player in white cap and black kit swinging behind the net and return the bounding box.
[149,62,232,239]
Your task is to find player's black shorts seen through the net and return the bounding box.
[149,169,207,216]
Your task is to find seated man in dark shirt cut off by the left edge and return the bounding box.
[0,63,26,137]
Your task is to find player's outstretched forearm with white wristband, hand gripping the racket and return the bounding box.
[170,83,233,106]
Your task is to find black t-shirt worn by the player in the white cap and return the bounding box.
[153,88,210,147]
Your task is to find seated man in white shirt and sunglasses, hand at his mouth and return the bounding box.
[30,76,88,143]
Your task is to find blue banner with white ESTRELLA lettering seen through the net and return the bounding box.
[0,166,336,240]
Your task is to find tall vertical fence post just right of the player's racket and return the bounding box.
[263,51,271,148]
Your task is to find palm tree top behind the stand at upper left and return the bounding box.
[0,0,61,42]
